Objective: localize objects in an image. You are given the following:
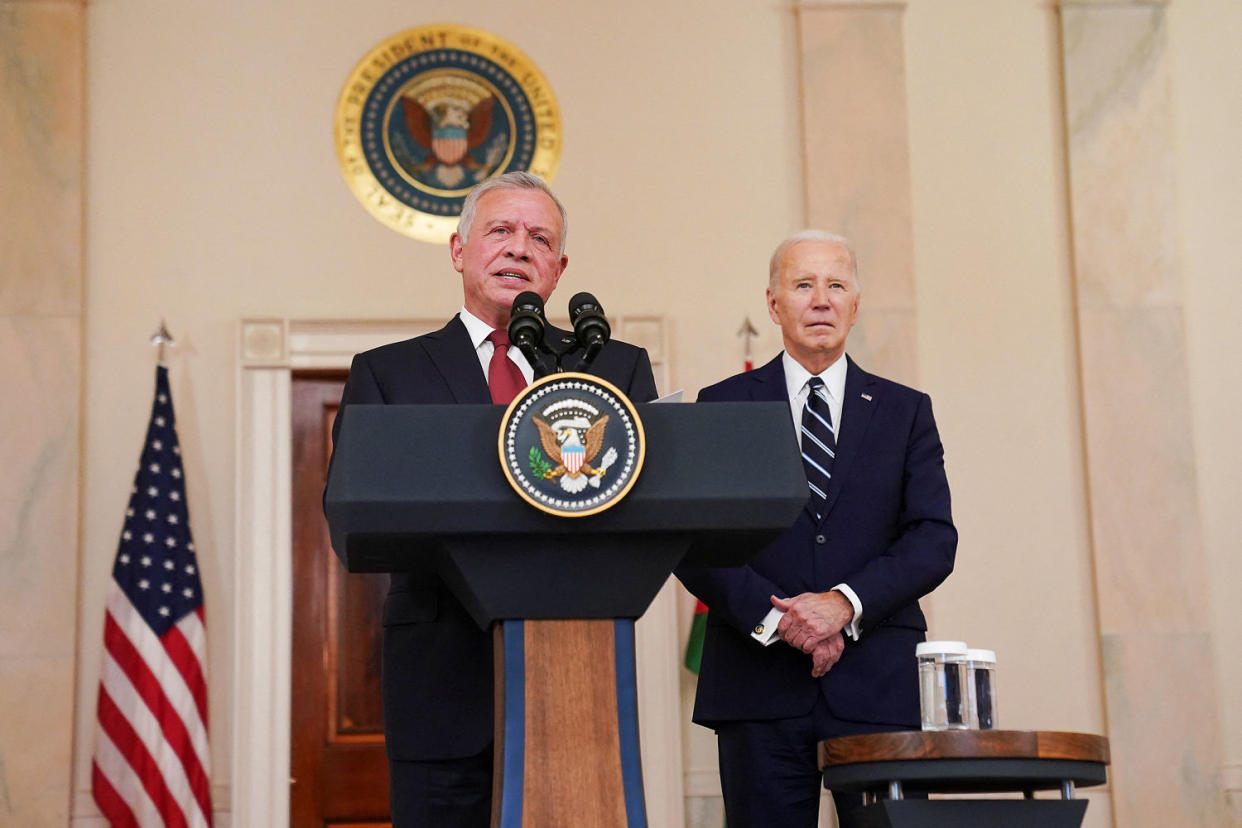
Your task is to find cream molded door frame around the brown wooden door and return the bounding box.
[233,315,684,828]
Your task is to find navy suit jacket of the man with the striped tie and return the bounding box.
[677,356,958,727]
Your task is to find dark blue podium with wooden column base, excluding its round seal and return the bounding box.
[324,402,807,828]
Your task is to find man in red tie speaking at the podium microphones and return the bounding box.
[333,173,656,828]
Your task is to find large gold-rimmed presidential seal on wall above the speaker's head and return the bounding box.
[335,25,560,243]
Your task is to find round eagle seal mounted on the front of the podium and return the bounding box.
[501,374,646,518]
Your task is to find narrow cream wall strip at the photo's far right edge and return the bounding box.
[1169,0,1242,809]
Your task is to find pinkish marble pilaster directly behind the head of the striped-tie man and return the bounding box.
[796,0,918,385]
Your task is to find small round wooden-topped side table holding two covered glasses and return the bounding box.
[820,730,1109,828]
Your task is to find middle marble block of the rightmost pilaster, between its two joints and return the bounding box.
[1079,307,1210,634]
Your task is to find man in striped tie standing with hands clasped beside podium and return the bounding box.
[677,231,958,828]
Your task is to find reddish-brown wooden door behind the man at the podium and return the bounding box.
[289,372,389,828]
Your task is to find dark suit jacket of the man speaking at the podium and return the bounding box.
[333,317,656,760]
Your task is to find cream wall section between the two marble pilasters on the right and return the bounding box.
[907,1,1110,826]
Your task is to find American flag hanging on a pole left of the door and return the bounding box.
[91,365,211,828]
